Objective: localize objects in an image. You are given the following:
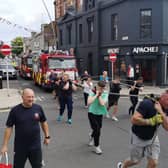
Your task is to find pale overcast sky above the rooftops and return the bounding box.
[0,0,54,43]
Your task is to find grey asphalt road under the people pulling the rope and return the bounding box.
[0,79,168,168]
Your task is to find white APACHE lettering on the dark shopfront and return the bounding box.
[132,46,159,54]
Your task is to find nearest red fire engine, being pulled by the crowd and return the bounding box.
[33,50,78,90]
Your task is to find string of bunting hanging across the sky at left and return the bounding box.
[0,17,36,33]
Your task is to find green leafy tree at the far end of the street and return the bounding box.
[11,37,23,56]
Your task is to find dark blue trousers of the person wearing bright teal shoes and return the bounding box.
[60,96,73,119]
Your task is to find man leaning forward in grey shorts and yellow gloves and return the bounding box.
[117,91,168,168]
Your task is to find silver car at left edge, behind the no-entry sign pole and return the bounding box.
[0,64,17,79]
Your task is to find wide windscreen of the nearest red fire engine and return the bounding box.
[48,58,76,69]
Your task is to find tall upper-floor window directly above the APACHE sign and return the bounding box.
[140,9,152,39]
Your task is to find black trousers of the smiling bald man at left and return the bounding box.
[14,149,42,168]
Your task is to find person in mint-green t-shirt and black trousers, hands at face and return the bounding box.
[88,81,108,154]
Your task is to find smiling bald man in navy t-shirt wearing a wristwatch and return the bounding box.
[1,88,50,168]
